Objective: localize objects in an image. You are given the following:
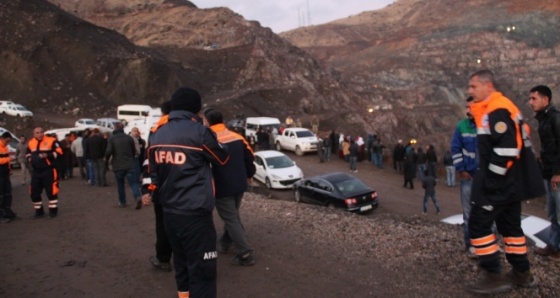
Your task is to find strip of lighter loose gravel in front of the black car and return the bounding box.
[242,193,560,297]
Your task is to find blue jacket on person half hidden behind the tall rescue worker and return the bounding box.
[451,118,478,176]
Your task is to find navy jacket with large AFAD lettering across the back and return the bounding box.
[148,111,229,214]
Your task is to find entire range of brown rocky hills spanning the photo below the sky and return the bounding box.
[0,0,560,154]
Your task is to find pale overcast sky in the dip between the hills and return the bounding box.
[190,0,394,33]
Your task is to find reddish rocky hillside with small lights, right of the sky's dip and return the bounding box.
[282,0,560,148]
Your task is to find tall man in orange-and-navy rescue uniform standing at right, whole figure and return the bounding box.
[467,70,544,294]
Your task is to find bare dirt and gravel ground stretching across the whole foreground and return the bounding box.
[0,156,560,297]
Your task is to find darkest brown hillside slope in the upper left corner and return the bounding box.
[0,0,200,121]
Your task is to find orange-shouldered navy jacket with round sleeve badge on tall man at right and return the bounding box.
[471,92,543,206]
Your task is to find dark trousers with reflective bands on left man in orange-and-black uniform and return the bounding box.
[31,168,58,214]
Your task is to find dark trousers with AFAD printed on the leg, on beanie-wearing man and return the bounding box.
[163,211,218,297]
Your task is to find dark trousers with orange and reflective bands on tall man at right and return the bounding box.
[468,202,530,273]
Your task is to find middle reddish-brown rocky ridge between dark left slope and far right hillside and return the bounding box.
[26,0,364,135]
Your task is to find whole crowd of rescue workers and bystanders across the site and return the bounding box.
[0,70,560,297]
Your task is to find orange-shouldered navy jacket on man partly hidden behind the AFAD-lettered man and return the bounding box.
[210,123,256,199]
